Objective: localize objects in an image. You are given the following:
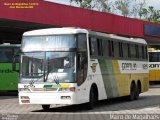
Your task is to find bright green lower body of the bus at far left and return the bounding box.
[0,63,18,91]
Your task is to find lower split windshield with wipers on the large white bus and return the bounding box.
[21,51,76,83]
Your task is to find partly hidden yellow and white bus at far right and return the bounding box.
[148,45,160,82]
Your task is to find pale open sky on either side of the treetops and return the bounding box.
[45,0,160,10]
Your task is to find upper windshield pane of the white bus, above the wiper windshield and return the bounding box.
[22,35,76,52]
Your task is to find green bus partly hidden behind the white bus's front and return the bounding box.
[0,43,20,92]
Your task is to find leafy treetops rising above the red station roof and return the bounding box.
[70,0,160,22]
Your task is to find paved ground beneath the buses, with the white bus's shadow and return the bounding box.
[0,85,160,120]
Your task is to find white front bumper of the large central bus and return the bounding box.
[19,92,77,105]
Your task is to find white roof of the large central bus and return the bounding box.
[23,27,147,44]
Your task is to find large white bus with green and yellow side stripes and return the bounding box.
[18,28,149,109]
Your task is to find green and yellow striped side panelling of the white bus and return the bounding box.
[99,59,149,98]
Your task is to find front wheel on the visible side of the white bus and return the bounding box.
[87,87,96,109]
